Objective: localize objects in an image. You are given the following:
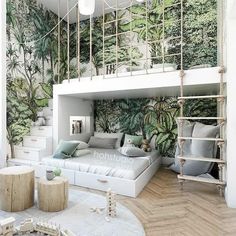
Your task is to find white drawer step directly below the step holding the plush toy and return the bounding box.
[23,136,52,152]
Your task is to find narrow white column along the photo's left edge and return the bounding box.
[0,0,6,167]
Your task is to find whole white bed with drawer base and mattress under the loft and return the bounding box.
[36,148,161,197]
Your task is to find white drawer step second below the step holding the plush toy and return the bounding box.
[14,146,50,161]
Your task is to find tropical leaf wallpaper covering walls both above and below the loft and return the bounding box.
[7,0,217,159]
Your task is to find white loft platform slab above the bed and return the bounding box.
[54,67,226,100]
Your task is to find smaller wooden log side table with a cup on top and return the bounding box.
[38,177,69,212]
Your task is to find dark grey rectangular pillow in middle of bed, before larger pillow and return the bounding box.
[88,136,117,149]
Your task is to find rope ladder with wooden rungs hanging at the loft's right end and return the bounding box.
[177,0,226,196]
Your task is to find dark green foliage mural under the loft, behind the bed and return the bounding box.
[95,97,217,157]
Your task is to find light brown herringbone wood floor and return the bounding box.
[71,168,236,236]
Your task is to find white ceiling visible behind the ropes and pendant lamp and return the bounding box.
[37,0,134,24]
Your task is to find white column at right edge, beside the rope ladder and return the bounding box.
[226,0,236,208]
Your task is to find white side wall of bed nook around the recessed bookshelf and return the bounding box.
[53,93,93,150]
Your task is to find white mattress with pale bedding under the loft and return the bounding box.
[42,148,159,180]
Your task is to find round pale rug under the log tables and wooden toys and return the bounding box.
[0,189,145,236]
